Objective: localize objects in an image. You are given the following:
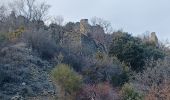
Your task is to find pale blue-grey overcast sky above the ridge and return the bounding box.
[1,0,170,40]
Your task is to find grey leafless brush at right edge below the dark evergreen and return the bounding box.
[131,57,170,93]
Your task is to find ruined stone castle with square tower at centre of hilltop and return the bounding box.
[61,19,104,54]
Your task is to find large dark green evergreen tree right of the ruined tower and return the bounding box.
[109,31,164,71]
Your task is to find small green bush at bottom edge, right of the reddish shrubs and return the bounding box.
[121,83,143,100]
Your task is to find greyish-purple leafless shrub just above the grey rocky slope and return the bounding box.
[24,30,59,59]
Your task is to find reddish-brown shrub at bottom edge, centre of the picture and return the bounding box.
[76,83,119,100]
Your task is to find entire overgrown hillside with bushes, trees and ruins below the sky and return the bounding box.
[0,0,170,100]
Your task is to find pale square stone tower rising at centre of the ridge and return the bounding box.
[80,19,90,36]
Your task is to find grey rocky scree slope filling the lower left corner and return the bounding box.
[0,43,55,100]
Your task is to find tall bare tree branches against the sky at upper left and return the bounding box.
[9,0,50,20]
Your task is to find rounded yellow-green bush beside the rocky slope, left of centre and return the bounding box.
[51,64,82,93]
